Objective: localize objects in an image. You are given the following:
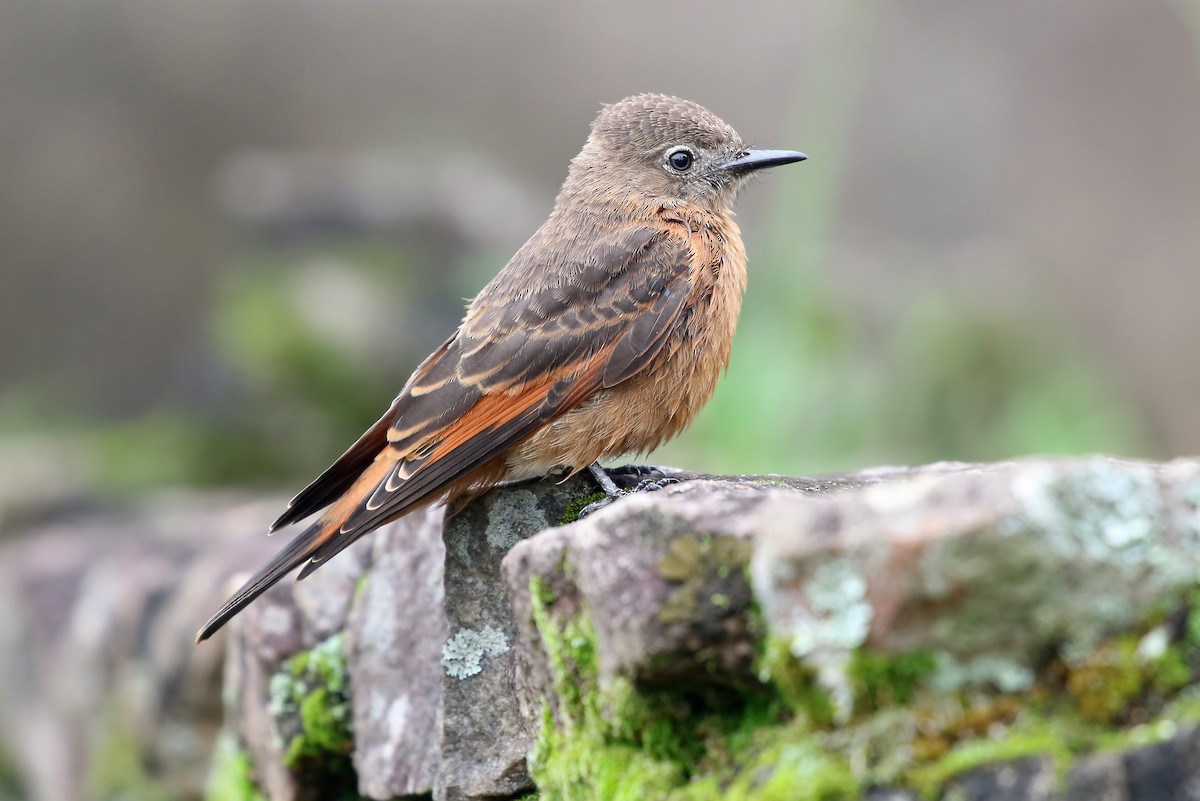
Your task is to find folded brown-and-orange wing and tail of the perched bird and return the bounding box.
[198,229,691,639]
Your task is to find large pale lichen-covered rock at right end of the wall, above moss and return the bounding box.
[751,458,1200,714]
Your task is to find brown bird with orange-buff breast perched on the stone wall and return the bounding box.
[196,94,806,643]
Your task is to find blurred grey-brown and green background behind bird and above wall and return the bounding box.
[0,0,1200,797]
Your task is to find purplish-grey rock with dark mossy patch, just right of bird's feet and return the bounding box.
[504,478,803,707]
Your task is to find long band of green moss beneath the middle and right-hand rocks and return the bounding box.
[533,606,1200,801]
